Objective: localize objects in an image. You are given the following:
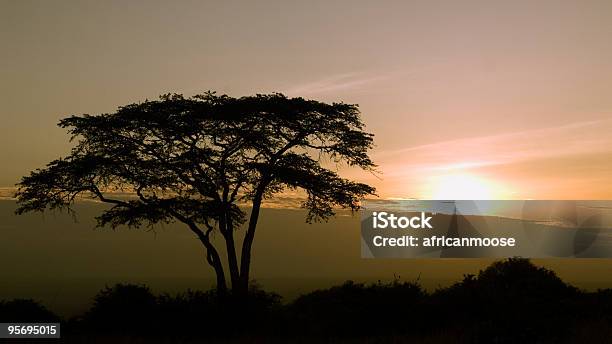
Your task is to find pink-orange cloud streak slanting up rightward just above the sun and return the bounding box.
[375,119,612,176]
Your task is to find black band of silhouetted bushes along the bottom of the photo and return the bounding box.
[0,258,612,343]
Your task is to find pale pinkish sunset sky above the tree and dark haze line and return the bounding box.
[0,1,612,199]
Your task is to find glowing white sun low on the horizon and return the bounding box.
[428,173,500,200]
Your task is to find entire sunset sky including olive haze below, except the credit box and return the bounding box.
[5,0,612,314]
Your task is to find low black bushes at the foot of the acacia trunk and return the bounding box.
[75,284,280,337]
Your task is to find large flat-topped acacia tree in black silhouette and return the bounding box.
[17,92,375,294]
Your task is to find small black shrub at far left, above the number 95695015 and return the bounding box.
[0,299,59,323]
